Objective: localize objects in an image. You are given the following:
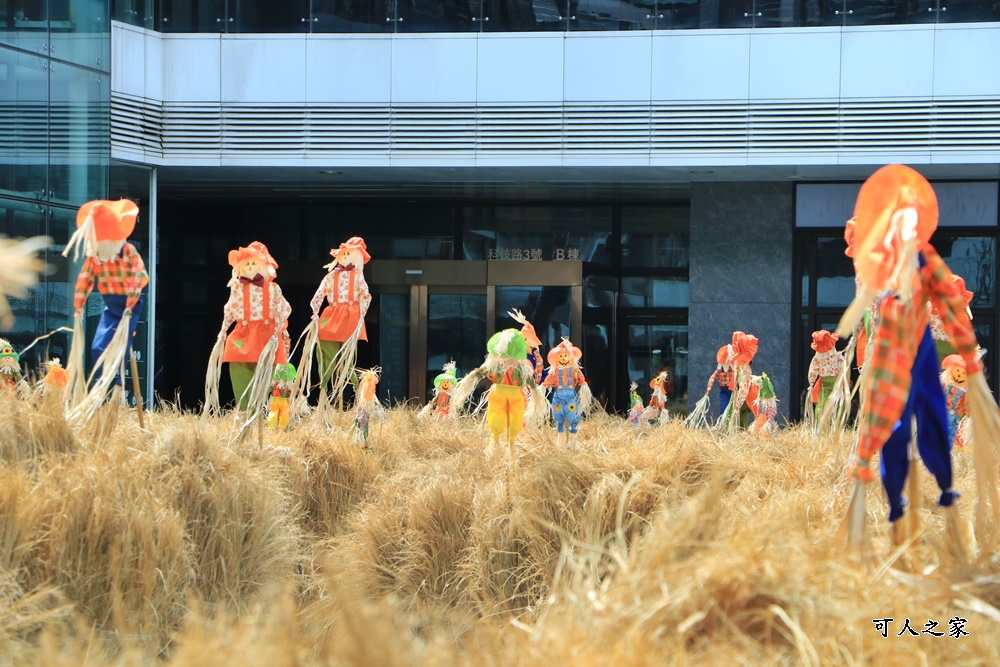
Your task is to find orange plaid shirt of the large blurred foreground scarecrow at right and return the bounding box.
[853,244,982,472]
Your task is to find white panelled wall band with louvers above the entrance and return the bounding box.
[112,23,1000,166]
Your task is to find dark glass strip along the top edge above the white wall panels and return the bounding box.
[113,0,1000,33]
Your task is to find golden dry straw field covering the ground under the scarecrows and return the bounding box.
[0,397,1000,667]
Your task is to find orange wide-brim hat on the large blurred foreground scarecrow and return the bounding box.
[845,164,938,290]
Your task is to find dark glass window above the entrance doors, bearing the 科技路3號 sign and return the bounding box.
[463,206,611,266]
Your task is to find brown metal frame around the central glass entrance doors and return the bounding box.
[365,260,583,405]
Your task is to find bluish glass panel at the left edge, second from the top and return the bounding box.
[0,47,49,200]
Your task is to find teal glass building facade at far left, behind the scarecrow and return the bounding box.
[0,0,150,402]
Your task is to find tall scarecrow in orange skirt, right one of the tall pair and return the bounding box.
[295,236,372,410]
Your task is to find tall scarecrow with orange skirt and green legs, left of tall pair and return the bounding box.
[205,241,292,423]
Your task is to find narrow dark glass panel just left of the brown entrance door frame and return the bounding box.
[377,294,410,405]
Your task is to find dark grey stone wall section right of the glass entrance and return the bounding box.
[688,183,794,422]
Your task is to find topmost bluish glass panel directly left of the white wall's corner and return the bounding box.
[49,0,111,72]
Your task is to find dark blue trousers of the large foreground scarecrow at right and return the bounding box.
[881,328,958,521]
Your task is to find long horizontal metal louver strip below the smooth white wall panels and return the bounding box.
[111,93,1000,163]
